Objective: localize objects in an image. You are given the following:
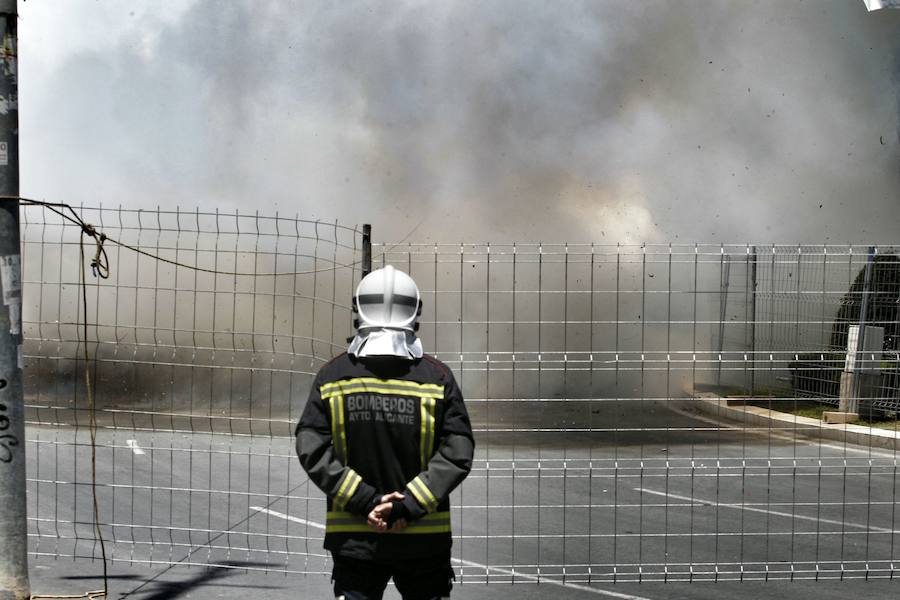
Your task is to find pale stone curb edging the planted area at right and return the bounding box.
[690,393,900,451]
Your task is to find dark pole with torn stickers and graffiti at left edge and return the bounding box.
[0,0,31,600]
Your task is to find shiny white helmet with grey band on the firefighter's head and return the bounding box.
[353,265,422,331]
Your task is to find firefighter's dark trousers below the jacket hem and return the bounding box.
[331,554,456,600]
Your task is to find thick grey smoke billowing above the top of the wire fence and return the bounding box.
[14,0,900,243]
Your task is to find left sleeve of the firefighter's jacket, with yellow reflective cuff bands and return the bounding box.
[295,376,381,515]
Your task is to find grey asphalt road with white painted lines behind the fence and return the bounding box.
[21,396,900,600]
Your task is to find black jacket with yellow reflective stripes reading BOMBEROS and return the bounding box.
[296,353,475,560]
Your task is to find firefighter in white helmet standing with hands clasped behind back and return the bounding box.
[296,266,475,600]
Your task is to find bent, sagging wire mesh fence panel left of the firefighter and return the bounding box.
[22,207,360,576]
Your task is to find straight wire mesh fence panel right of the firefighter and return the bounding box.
[382,244,900,583]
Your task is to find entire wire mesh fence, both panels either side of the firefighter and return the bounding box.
[22,207,900,584]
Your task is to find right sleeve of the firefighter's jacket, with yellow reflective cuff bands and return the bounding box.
[403,374,475,519]
